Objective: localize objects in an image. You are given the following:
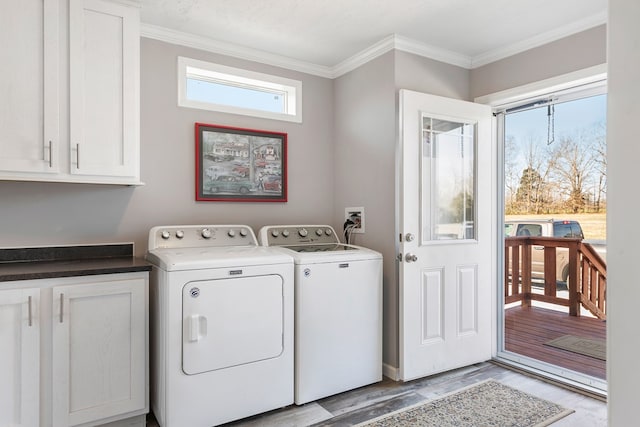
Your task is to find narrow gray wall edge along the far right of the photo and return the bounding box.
[607,0,640,426]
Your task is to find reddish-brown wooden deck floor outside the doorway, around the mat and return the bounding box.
[505,306,606,379]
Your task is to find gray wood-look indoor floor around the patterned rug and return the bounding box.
[147,362,607,427]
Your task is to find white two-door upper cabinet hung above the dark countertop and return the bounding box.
[0,0,140,185]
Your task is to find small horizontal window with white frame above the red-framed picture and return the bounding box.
[178,57,302,123]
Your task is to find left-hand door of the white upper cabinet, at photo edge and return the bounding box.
[0,0,61,174]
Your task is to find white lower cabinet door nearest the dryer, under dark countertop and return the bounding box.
[52,274,148,426]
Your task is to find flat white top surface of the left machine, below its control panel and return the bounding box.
[146,246,293,271]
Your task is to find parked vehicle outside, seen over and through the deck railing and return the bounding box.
[504,219,584,283]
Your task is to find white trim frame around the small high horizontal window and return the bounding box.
[178,56,302,123]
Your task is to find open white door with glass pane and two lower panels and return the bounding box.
[398,90,496,380]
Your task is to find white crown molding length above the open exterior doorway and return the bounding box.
[469,11,607,69]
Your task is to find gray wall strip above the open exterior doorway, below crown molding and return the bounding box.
[471,25,607,99]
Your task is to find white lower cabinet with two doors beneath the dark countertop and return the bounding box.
[0,272,149,427]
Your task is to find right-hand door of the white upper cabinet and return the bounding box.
[69,0,140,183]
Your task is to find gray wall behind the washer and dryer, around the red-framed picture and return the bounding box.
[0,38,334,255]
